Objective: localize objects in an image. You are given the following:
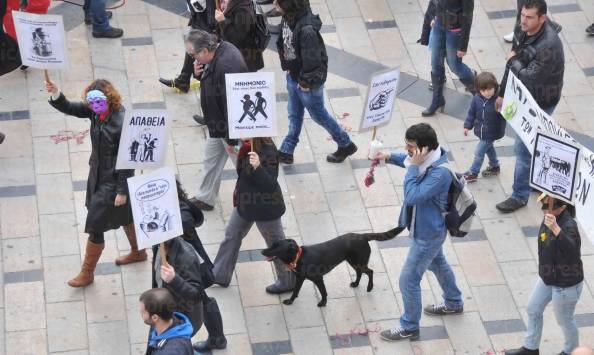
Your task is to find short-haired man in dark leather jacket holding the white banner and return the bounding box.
[496,0,565,213]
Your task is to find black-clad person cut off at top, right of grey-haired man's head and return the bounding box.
[215,0,264,72]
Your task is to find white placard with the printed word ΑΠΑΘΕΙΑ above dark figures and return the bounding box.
[116,110,170,169]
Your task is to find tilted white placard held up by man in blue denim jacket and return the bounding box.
[359,68,400,132]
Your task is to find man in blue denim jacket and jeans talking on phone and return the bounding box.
[378,123,463,341]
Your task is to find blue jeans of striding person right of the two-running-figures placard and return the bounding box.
[279,74,351,154]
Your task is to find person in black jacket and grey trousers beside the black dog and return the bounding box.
[213,138,295,294]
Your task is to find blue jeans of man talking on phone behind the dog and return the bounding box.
[399,233,464,331]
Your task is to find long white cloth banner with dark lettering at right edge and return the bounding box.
[501,72,594,243]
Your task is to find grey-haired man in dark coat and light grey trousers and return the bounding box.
[185,29,247,211]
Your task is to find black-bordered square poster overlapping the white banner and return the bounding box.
[530,131,580,203]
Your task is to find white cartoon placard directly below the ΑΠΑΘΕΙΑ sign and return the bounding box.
[128,168,184,249]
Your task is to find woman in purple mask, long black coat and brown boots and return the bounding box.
[45,79,146,287]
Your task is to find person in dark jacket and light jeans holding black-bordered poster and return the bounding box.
[505,193,584,355]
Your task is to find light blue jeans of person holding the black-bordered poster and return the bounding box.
[524,277,584,354]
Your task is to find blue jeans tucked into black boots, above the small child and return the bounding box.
[431,21,474,86]
